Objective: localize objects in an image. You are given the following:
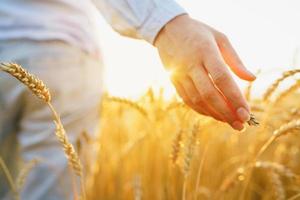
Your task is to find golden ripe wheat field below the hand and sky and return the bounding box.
[0,63,300,200]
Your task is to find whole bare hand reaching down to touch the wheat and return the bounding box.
[154,15,256,130]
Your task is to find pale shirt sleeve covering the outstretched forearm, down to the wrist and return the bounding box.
[94,0,186,44]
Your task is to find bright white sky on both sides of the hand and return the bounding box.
[96,0,300,97]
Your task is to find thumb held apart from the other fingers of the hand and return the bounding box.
[216,34,256,81]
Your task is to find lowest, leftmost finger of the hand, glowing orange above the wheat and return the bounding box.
[172,77,224,121]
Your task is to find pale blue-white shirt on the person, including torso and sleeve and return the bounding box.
[0,0,185,53]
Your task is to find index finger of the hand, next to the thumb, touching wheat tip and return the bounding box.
[204,43,250,122]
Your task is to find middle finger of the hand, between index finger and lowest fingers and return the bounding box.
[190,67,244,130]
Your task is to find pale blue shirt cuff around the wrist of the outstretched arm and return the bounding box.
[139,0,187,44]
